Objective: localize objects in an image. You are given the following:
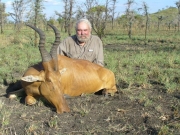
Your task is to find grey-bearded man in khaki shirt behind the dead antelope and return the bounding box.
[58,19,104,66]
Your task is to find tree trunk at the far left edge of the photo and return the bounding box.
[0,0,6,34]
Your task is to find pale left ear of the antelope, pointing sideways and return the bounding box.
[21,75,45,82]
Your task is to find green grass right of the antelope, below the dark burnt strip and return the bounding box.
[105,45,180,92]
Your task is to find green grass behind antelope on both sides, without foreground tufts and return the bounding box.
[0,25,180,92]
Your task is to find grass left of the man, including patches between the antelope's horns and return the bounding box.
[0,28,69,84]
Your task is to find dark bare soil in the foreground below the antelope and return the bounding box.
[0,44,180,135]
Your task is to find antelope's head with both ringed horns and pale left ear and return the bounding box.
[22,24,70,113]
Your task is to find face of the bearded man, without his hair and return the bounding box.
[76,22,91,42]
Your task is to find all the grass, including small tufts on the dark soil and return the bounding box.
[0,24,180,135]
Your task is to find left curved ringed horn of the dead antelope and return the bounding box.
[26,24,52,62]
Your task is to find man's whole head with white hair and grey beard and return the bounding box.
[75,19,91,43]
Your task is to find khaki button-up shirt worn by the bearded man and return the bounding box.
[57,35,104,66]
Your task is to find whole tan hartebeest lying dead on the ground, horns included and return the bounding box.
[9,25,117,113]
